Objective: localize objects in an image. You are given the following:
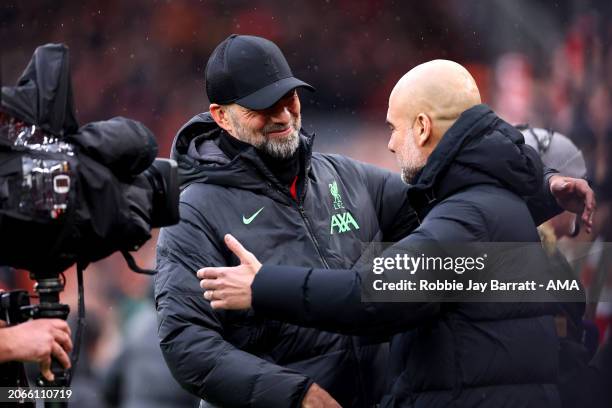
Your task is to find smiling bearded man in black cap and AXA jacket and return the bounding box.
[155,35,596,407]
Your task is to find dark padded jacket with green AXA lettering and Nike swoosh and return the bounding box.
[155,114,416,408]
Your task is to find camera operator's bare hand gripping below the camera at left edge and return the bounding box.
[0,319,72,381]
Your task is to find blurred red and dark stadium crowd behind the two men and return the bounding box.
[0,0,612,406]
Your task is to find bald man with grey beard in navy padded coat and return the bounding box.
[198,60,584,408]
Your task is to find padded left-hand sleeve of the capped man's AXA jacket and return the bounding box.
[155,203,312,408]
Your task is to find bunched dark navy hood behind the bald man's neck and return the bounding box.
[408,104,543,220]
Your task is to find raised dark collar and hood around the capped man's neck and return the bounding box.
[170,112,315,201]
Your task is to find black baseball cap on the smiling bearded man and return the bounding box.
[205,34,315,110]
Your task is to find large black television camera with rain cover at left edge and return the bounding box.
[0,44,179,276]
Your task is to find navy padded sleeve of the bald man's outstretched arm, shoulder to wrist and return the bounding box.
[251,200,494,335]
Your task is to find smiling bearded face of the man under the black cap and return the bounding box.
[210,89,302,159]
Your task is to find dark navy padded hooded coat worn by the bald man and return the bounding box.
[252,105,559,408]
